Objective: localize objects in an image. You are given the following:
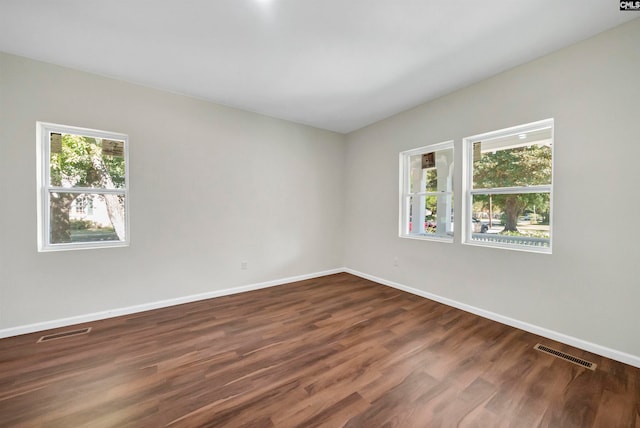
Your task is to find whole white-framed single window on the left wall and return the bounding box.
[37,122,129,251]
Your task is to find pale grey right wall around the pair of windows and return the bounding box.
[345,20,640,361]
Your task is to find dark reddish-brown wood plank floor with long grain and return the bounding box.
[0,274,640,428]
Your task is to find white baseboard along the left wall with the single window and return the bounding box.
[0,268,345,338]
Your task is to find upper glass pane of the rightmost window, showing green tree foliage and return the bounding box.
[472,128,552,189]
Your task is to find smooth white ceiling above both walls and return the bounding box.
[0,0,638,132]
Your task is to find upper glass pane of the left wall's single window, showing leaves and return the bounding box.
[49,133,126,189]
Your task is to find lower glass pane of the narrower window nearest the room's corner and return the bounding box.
[408,193,453,237]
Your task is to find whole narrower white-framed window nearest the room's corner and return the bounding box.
[400,141,453,242]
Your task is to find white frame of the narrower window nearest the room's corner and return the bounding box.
[398,140,455,243]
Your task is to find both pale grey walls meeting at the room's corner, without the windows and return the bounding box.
[0,20,640,361]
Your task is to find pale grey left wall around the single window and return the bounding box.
[0,54,345,330]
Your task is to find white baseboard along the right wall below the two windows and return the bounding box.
[344,268,640,368]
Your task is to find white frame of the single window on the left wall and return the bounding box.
[36,122,130,252]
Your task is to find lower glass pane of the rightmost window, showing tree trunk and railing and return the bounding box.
[470,193,551,247]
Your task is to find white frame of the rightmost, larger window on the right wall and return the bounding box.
[462,119,555,254]
